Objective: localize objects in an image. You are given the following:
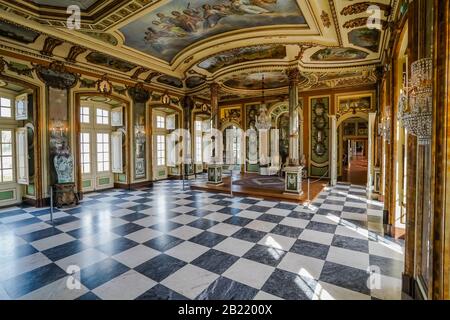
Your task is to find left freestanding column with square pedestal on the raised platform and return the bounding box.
[208,83,222,184]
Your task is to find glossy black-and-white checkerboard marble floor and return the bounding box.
[0,181,403,300]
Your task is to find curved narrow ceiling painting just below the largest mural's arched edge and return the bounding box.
[198,45,286,73]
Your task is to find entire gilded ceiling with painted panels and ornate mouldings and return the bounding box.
[0,0,404,98]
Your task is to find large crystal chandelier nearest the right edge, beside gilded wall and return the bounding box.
[399,58,433,145]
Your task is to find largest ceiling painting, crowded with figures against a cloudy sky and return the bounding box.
[120,0,306,62]
